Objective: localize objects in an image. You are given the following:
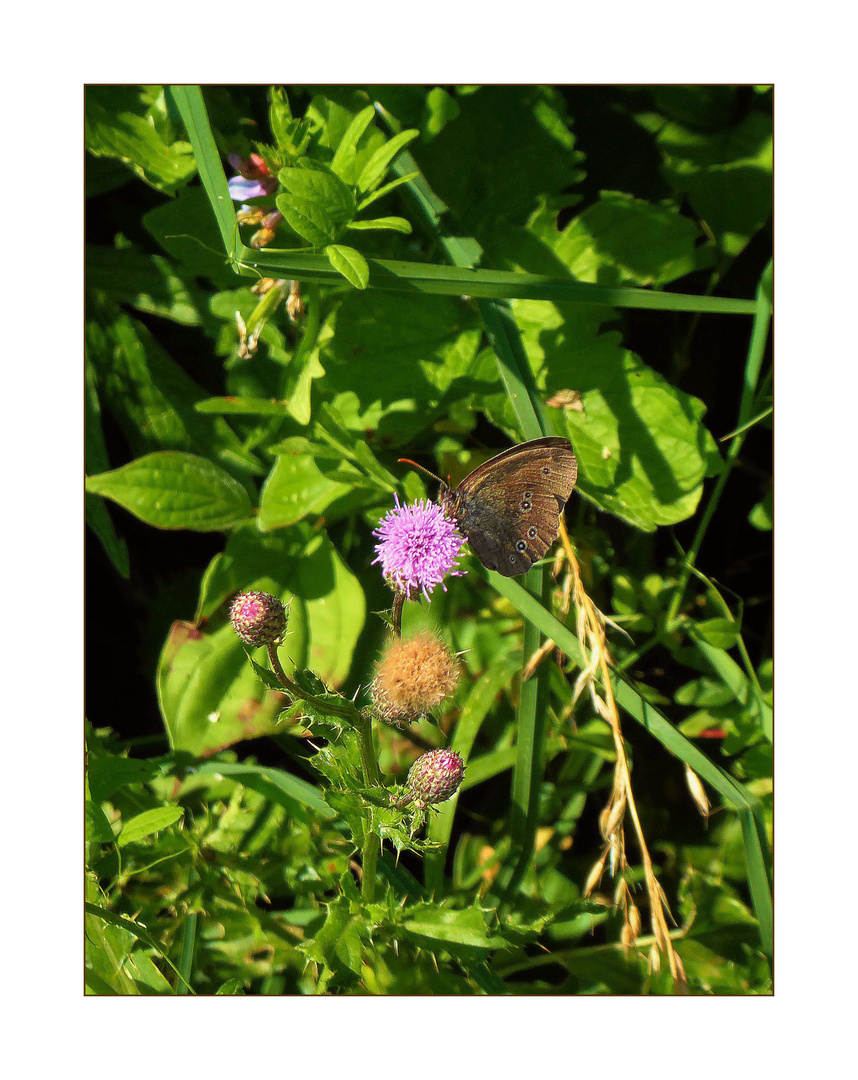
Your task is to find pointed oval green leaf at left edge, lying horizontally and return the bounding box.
[86,451,253,532]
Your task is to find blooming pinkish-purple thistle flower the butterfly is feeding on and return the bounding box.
[373,496,465,599]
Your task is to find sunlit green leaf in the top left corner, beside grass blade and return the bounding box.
[84,84,197,193]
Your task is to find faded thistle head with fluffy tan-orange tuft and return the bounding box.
[372,630,460,727]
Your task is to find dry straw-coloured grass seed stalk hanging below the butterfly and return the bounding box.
[560,518,687,993]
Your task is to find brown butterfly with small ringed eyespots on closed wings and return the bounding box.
[400,437,578,578]
